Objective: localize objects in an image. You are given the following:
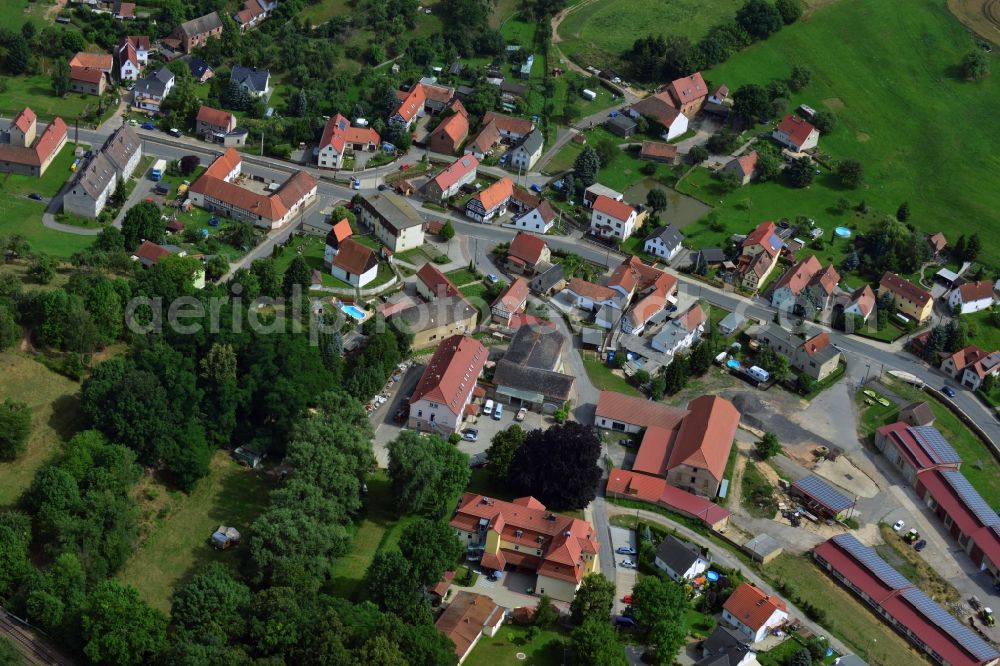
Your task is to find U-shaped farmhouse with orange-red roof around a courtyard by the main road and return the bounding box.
[188,148,317,229]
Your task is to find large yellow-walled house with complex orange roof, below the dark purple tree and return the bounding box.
[449,493,600,603]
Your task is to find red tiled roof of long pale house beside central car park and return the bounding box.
[410,335,489,415]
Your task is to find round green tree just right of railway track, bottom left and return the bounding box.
[81,579,167,666]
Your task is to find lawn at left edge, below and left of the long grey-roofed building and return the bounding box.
[0,143,94,259]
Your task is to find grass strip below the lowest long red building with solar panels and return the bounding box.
[767,553,924,666]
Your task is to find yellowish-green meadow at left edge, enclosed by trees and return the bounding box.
[0,350,80,509]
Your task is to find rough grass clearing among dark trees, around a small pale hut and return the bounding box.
[118,451,268,611]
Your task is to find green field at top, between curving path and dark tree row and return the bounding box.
[559,0,743,67]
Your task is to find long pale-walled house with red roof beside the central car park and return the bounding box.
[408,335,489,438]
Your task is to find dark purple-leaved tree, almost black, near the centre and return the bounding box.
[507,421,601,509]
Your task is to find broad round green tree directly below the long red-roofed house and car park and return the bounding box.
[388,430,469,516]
